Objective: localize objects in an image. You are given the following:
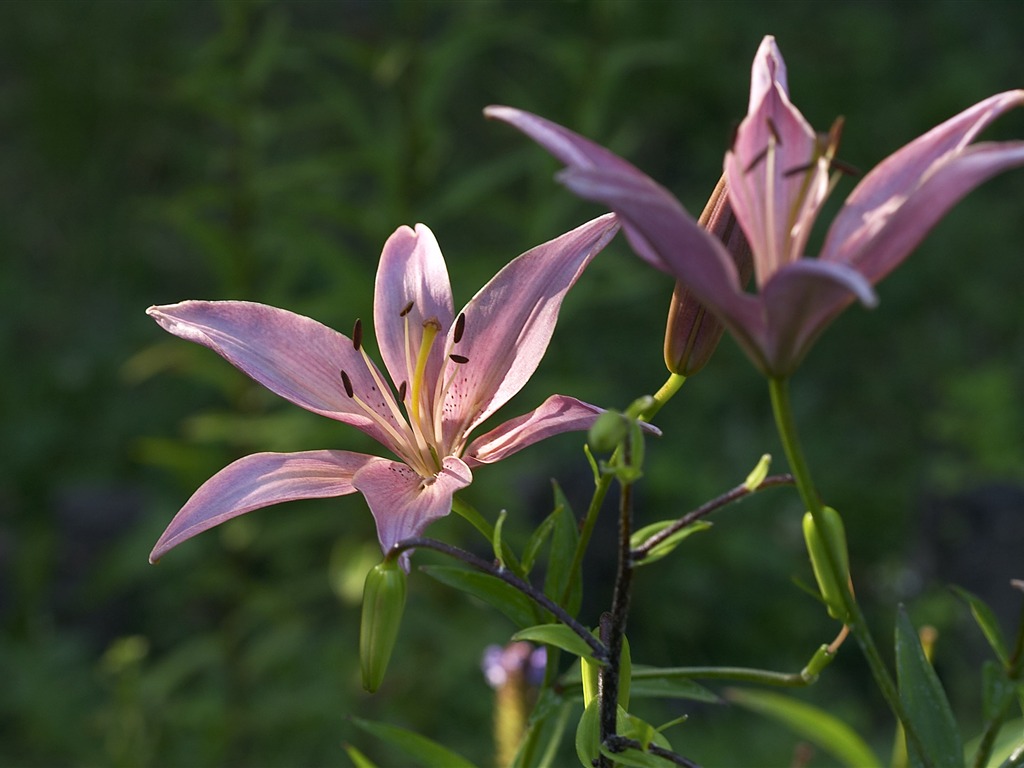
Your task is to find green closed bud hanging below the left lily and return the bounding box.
[359,560,406,693]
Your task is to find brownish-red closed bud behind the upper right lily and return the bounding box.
[665,175,754,376]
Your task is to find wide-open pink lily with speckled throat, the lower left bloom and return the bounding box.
[147,214,618,565]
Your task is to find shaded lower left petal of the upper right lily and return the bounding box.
[560,169,765,370]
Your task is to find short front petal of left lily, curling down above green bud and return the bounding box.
[352,457,473,570]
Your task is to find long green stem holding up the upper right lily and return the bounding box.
[768,379,927,755]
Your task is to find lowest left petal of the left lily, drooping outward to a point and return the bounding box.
[150,451,375,562]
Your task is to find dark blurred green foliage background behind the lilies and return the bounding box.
[0,0,1024,766]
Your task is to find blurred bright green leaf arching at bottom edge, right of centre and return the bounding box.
[725,688,881,768]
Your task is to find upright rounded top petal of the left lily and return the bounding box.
[374,224,454,399]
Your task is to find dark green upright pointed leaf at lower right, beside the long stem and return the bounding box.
[896,605,964,768]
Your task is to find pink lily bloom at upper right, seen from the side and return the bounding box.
[484,37,1024,378]
